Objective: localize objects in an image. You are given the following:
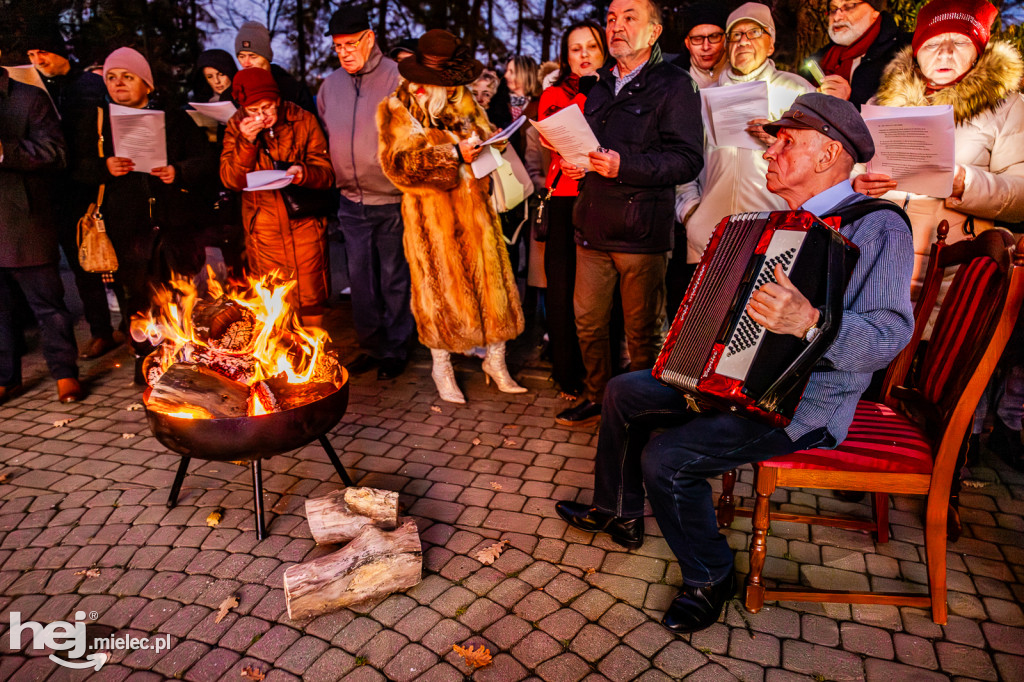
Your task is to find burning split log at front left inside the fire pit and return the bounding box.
[145,363,249,419]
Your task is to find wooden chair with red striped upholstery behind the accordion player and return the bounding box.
[735,226,1024,625]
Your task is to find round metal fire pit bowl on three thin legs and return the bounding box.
[143,369,353,540]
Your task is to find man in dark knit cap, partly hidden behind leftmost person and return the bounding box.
[28,26,118,358]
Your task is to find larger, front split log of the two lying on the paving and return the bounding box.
[285,521,423,621]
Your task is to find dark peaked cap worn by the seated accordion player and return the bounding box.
[764,92,874,164]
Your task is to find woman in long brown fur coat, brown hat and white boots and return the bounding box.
[377,30,526,403]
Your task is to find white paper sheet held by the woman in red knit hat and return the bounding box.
[861,104,956,199]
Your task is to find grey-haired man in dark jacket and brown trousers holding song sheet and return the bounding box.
[556,0,703,425]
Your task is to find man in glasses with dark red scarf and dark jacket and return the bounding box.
[802,0,910,108]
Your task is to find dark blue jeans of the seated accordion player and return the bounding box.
[594,370,830,587]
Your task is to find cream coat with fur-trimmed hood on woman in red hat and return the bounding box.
[876,40,1024,300]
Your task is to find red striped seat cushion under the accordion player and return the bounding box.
[761,400,932,473]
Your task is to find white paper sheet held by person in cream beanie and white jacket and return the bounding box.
[700,81,769,151]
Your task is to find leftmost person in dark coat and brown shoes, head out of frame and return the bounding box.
[0,62,82,402]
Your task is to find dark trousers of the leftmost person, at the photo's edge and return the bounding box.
[0,263,78,386]
